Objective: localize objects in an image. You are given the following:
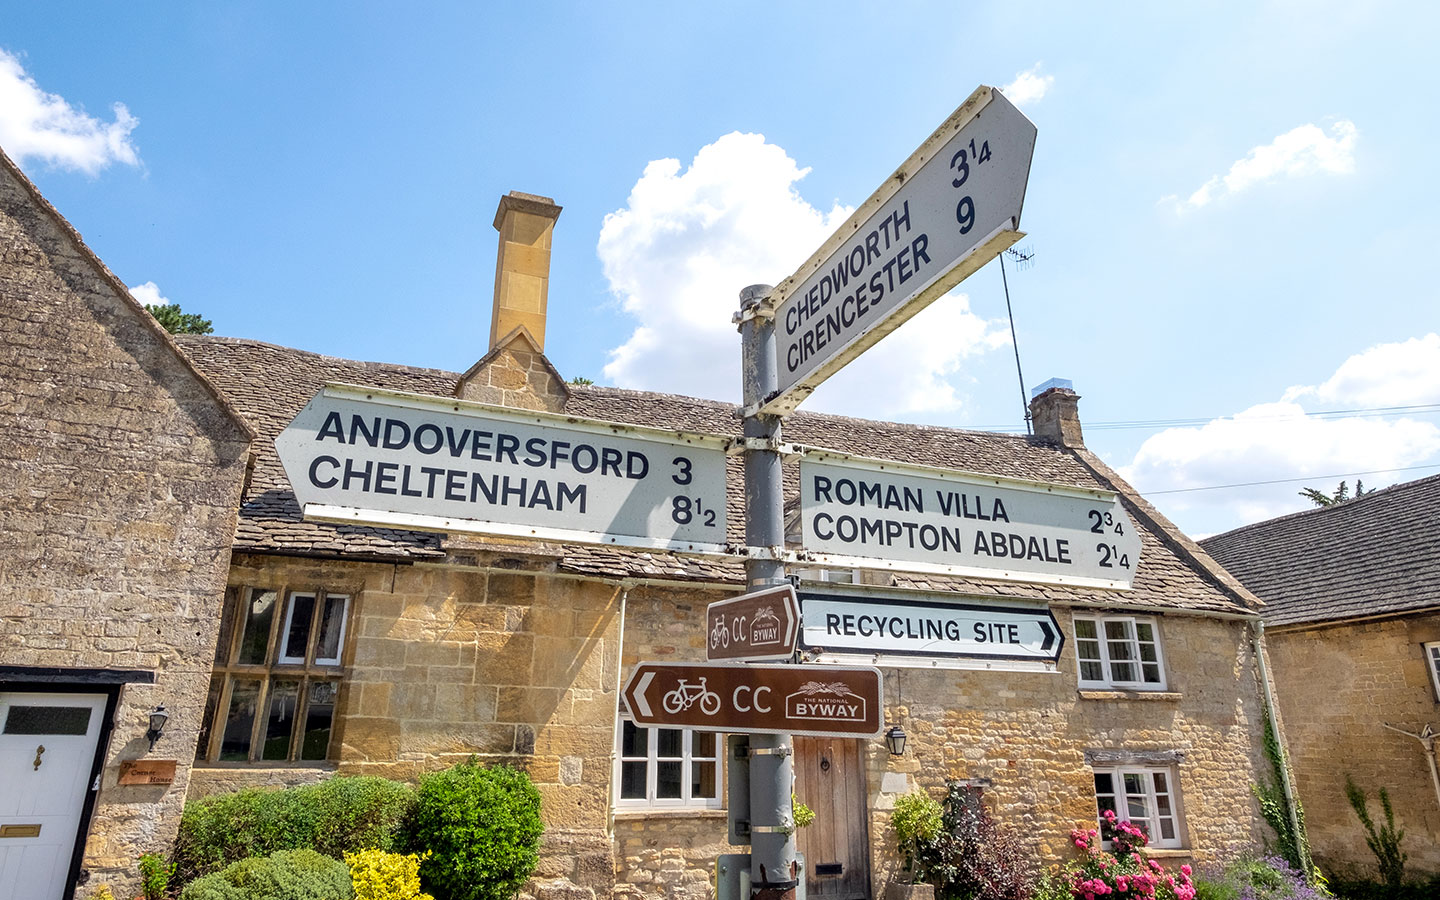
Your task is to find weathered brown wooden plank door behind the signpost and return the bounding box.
[795,737,870,900]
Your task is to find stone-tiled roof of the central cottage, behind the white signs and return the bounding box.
[180,336,1259,612]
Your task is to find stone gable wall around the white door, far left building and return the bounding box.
[0,161,249,894]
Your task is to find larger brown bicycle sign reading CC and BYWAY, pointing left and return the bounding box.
[625,662,884,737]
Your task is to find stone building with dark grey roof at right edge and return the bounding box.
[1204,475,1440,877]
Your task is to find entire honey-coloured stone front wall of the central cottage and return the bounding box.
[203,541,1264,900]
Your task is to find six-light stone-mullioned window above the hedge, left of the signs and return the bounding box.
[196,588,350,763]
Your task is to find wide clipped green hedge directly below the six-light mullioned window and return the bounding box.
[174,778,415,883]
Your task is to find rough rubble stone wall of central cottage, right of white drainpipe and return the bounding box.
[615,592,1266,900]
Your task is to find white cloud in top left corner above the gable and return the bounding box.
[0,50,140,176]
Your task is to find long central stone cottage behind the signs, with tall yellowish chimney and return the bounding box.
[165,194,1284,900]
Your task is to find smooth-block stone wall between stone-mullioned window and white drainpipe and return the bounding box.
[218,554,621,897]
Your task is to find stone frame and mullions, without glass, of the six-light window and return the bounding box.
[196,579,359,768]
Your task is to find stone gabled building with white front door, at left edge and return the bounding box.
[0,144,252,900]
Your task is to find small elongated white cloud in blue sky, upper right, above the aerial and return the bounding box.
[1165,120,1359,212]
